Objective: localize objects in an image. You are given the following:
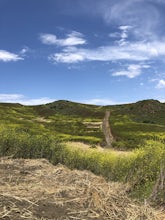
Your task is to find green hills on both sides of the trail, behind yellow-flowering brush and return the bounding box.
[0,100,165,149]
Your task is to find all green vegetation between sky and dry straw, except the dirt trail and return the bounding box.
[0,100,165,204]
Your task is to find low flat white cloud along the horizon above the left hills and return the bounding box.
[0,94,55,105]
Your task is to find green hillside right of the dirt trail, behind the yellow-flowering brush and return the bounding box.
[106,100,165,148]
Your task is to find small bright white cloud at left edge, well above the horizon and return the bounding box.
[0,50,23,62]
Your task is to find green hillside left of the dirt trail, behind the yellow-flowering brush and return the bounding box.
[0,101,104,144]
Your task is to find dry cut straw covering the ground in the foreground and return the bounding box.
[0,158,165,220]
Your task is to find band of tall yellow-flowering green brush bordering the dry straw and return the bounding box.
[0,129,165,204]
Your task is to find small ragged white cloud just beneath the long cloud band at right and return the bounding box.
[112,64,149,78]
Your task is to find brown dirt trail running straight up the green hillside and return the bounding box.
[102,110,114,147]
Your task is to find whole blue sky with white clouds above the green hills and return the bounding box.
[0,0,165,105]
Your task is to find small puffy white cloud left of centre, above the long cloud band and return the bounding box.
[40,31,86,46]
